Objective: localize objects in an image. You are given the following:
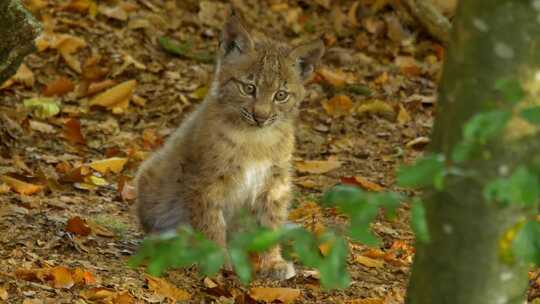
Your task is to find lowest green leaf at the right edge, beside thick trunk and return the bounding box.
[512,221,540,265]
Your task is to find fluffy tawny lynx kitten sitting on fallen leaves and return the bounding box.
[136,13,324,279]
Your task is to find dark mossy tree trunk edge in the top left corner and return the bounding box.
[0,0,41,84]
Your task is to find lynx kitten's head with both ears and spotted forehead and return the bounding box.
[216,16,324,128]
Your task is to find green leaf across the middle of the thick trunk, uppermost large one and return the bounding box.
[463,110,512,144]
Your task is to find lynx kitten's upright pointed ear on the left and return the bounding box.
[219,8,254,58]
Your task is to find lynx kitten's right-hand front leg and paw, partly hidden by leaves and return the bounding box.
[256,168,295,280]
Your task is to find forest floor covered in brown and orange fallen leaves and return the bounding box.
[0,0,538,304]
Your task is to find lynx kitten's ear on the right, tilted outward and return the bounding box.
[289,39,324,80]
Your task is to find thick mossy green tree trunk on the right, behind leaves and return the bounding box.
[406,0,540,304]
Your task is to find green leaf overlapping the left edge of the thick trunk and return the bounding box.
[397,154,445,187]
